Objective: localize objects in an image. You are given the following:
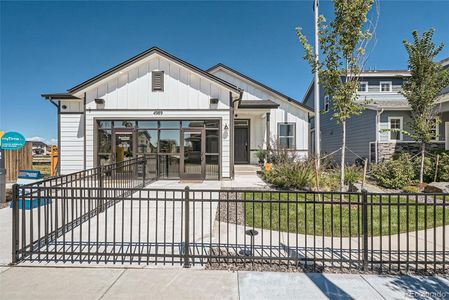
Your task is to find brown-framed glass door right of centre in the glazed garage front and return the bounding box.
[181,129,206,180]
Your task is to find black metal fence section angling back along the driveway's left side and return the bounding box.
[11,157,150,262]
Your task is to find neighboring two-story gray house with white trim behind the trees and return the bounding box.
[303,59,449,164]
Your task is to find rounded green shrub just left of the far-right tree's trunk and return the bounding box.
[371,153,415,189]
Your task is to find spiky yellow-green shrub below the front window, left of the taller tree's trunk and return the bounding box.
[264,161,314,189]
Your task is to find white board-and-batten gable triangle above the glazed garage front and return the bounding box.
[82,55,230,109]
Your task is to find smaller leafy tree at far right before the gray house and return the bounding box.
[401,29,449,183]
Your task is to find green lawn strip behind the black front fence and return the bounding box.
[243,193,449,237]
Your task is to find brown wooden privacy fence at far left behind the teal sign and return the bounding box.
[5,142,33,182]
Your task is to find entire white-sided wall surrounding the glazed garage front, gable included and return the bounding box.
[60,54,231,177]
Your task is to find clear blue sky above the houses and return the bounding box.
[0,0,449,141]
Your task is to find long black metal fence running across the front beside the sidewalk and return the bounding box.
[13,179,449,273]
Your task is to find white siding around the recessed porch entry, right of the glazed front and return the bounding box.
[212,69,309,157]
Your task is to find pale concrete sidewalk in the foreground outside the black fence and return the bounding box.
[0,266,449,299]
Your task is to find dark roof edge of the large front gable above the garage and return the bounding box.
[67,47,240,93]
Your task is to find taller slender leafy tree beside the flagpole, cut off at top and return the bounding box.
[296,0,377,189]
